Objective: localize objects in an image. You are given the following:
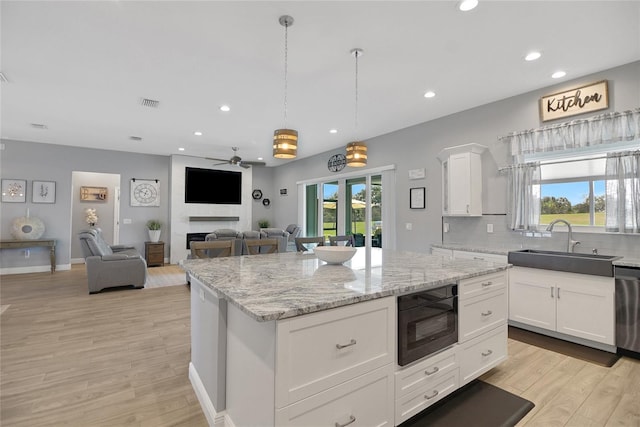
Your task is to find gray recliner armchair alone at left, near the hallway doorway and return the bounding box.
[78,228,147,294]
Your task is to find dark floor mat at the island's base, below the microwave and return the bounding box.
[400,380,535,427]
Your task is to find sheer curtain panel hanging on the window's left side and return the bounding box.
[509,162,540,230]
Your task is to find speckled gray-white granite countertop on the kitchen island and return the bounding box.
[180,248,508,322]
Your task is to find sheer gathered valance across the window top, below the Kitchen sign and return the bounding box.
[500,108,640,156]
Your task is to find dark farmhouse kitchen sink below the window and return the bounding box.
[508,249,622,277]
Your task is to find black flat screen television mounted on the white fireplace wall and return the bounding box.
[184,167,242,205]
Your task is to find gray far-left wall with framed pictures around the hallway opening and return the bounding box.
[0,140,169,271]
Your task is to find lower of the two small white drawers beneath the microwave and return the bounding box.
[396,368,458,424]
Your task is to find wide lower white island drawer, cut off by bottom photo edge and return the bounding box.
[275,364,394,427]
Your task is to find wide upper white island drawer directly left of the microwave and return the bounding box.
[276,297,396,408]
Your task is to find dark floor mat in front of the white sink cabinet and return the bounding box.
[509,326,620,368]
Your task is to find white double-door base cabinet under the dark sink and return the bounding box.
[509,267,615,345]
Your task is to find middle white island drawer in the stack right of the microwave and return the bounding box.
[458,289,509,343]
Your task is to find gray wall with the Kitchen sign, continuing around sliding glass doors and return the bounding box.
[273,62,640,252]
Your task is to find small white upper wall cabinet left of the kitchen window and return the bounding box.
[438,144,487,216]
